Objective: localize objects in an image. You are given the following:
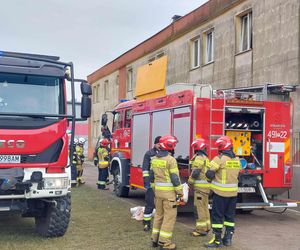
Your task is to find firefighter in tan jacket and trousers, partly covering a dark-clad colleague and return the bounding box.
[150,135,183,249]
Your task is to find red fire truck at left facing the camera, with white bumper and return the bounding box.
[0,52,92,237]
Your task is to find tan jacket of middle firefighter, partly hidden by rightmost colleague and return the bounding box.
[188,154,210,194]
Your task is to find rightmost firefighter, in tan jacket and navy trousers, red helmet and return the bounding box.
[205,136,241,248]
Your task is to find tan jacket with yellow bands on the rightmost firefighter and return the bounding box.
[209,154,241,197]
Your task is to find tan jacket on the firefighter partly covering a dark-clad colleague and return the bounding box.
[150,150,183,199]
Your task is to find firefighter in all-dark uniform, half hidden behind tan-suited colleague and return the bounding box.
[142,136,161,231]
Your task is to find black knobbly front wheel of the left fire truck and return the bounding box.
[35,195,71,237]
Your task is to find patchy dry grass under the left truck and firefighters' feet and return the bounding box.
[0,186,234,250]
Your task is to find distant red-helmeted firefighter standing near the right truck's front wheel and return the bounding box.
[97,138,109,190]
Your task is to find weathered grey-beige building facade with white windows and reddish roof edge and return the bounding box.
[88,0,300,162]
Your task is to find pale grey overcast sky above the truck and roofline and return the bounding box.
[0,0,207,79]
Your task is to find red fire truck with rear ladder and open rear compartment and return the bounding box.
[102,84,297,210]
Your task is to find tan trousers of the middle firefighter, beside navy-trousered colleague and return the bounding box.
[194,191,211,233]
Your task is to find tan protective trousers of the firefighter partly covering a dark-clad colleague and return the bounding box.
[151,192,177,247]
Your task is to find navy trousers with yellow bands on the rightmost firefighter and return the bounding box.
[211,193,237,234]
